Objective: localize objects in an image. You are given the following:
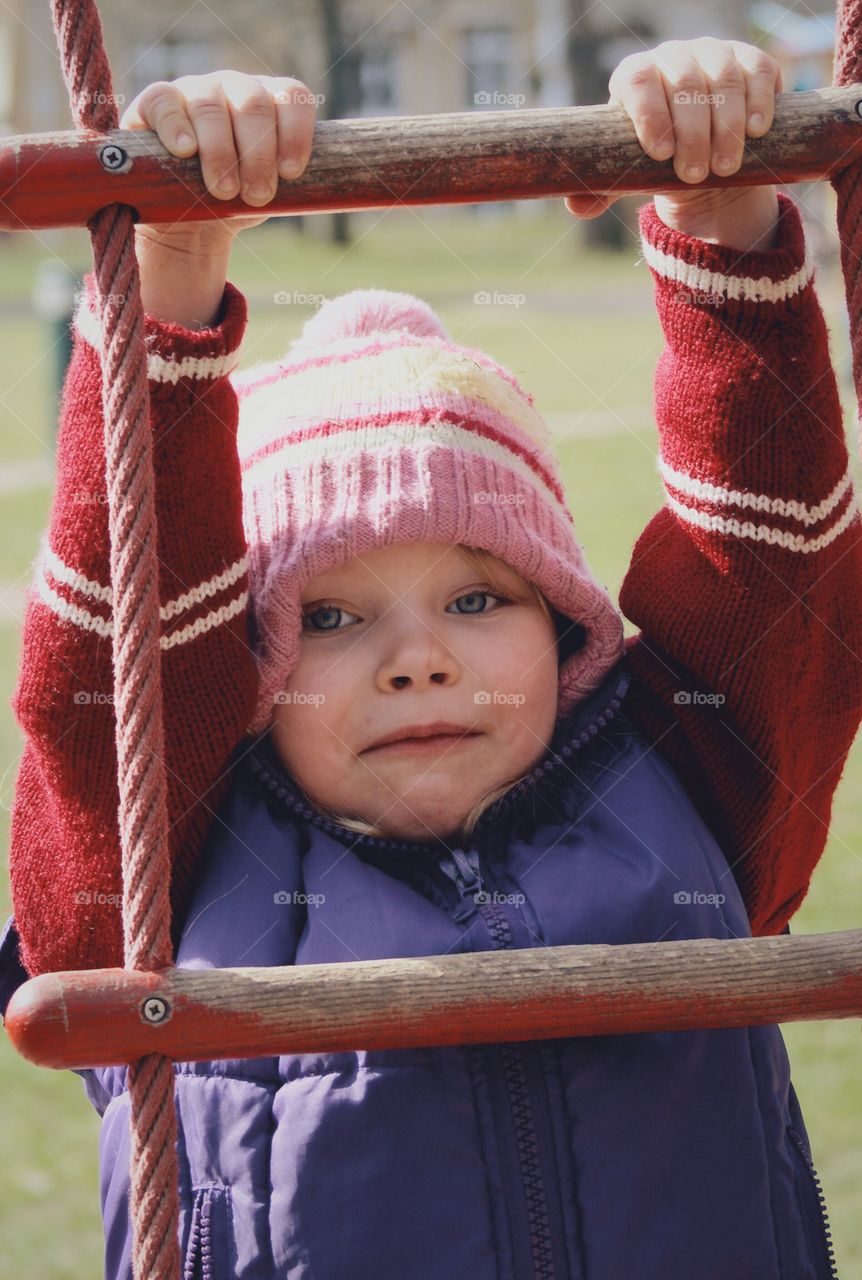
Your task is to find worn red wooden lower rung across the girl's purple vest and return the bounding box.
[6,929,862,1068]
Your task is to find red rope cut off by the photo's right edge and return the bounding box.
[831,0,862,411]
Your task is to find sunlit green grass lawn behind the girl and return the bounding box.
[0,202,862,1280]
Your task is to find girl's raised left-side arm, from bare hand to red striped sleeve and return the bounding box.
[6,70,315,974]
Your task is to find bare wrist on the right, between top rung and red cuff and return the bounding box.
[653,186,780,252]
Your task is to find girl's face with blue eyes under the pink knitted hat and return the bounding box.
[273,543,557,840]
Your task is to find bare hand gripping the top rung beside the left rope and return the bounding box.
[119,70,316,244]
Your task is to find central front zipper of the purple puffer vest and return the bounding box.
[439,849,558,1280]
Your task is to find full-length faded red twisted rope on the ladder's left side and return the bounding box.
[51,0,179,1280]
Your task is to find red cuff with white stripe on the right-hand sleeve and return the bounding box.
[638,191,815,307]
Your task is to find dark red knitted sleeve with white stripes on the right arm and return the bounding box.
[620,192,862,934]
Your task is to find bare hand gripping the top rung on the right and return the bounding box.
[566,36,784,235]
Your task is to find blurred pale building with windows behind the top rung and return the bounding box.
[0,0,834,248]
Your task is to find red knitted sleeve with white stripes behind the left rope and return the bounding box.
[10,273,256,977]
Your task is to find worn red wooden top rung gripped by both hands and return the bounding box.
[0,84,862,230]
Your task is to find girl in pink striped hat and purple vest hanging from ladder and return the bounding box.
[4,38,862,1280]
